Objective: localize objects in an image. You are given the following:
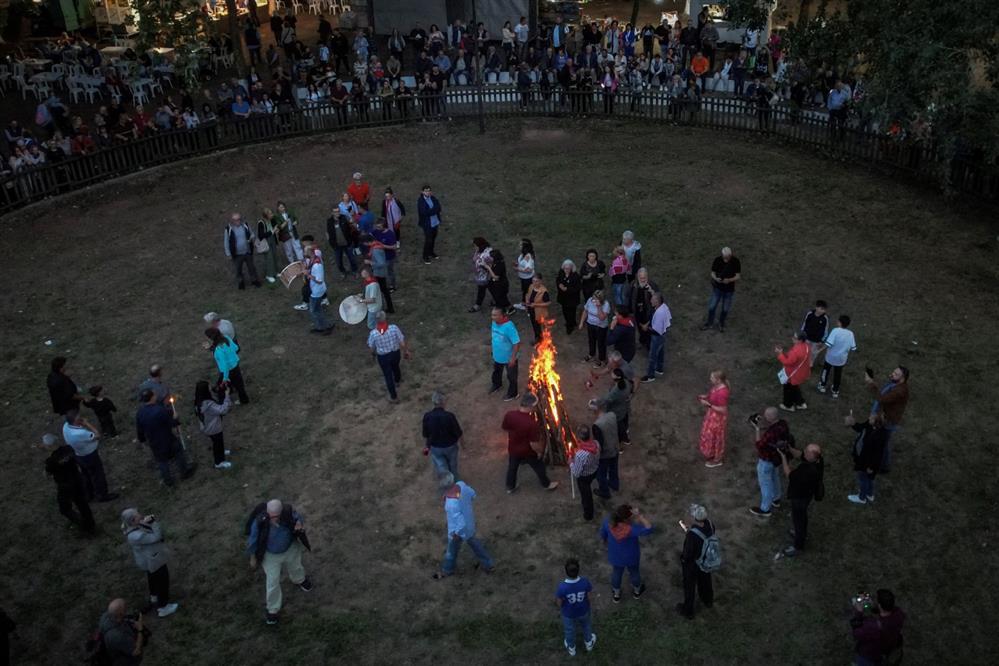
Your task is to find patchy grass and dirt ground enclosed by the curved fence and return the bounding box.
[0,121,999,666]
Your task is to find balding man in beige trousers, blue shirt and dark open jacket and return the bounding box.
[246,499,313,625]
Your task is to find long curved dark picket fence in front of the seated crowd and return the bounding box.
[0,87,999,214]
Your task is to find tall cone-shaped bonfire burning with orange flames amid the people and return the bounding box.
[528,321,576,465]
